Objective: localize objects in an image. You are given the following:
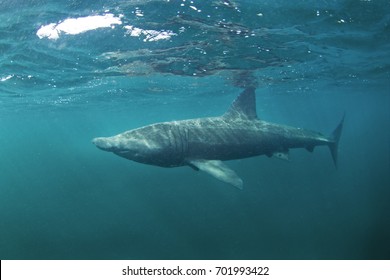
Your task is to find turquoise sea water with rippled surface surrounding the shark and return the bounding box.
[0,0,390,259]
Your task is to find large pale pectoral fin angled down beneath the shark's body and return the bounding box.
[188,159,243,190]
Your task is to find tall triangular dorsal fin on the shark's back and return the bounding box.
[223,87,257,120]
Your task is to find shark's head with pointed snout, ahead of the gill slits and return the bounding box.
[92,126,175,166]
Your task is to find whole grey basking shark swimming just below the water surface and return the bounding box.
[93,87,344,189]
